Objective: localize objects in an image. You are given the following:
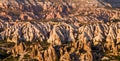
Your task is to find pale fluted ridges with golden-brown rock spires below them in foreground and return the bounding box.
[0,22,120,61]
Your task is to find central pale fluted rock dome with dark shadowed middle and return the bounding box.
[48,25,74,45]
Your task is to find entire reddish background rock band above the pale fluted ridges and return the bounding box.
[0,0,120,22]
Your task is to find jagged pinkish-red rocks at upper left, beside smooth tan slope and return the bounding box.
[0,0,72,21]
